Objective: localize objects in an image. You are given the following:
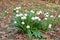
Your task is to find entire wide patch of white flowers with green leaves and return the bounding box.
[11,7,60,37]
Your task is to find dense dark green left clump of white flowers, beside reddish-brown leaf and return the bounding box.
[14,10,44,37]
